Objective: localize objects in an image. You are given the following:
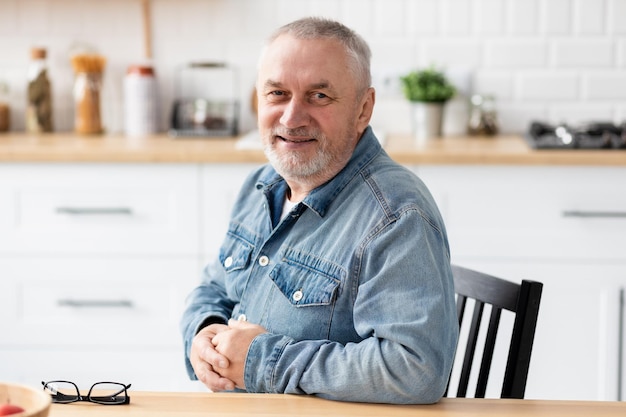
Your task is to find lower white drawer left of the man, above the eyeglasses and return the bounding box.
[0,258,198,390]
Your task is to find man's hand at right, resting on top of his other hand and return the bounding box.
[212,319,267,389]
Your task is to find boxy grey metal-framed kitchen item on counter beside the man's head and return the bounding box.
[169,62,239,137]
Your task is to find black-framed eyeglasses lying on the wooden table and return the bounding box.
[41,381,130,405]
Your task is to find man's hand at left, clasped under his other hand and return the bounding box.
[189,324,235,391]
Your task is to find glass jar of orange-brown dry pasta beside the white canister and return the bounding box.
[74,72,102,134]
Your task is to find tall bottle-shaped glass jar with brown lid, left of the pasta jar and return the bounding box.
[26,48,52,133]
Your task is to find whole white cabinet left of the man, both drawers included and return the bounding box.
[0,163,201,390]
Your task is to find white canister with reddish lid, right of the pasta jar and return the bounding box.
[124,65,158,136]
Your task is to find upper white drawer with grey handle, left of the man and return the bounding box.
[0,164,198,254]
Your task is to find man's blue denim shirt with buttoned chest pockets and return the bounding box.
[181,128,458,403]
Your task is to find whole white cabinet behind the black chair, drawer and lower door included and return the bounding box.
[416,166,626,400]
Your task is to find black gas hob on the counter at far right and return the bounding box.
[525,121,626,149]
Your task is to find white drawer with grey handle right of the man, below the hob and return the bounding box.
[418,167,626,259]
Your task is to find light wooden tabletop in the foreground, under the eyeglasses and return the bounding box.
[50,391,626,417]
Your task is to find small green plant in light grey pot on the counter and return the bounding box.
[400,66,456,142]
